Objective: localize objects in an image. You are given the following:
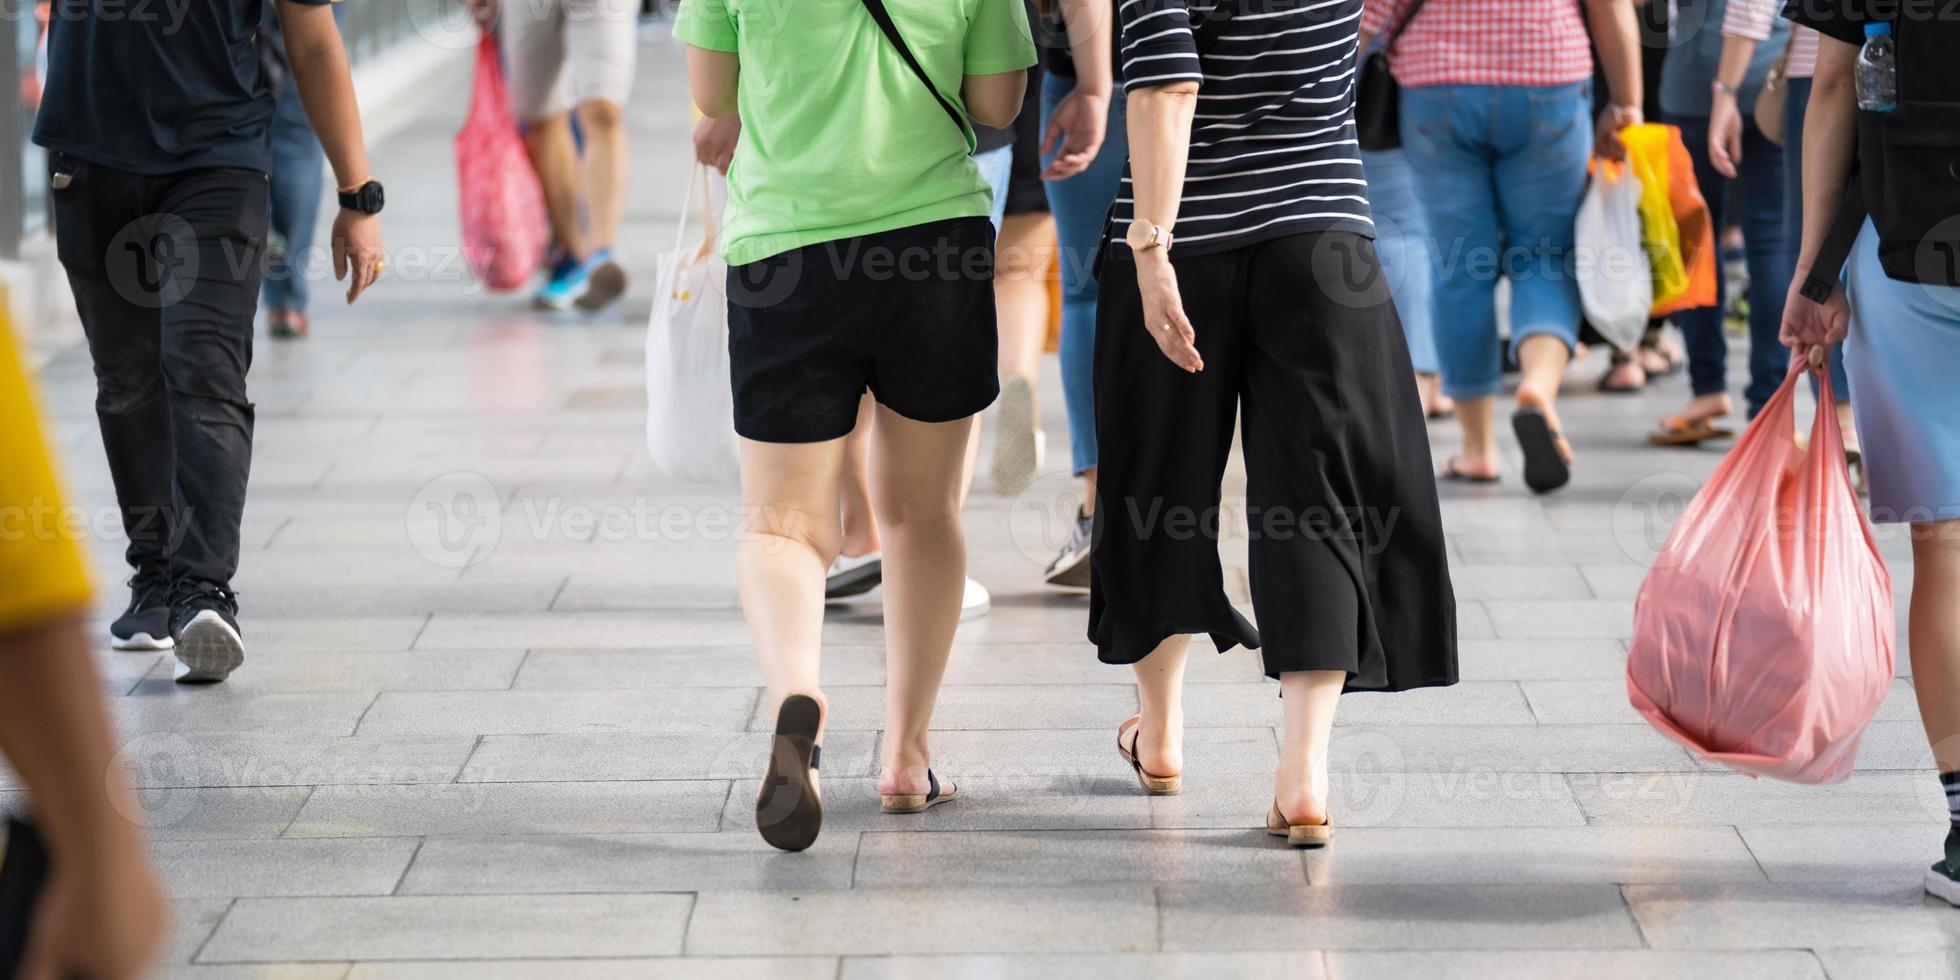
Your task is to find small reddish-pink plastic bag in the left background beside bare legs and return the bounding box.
[457,33,551,292]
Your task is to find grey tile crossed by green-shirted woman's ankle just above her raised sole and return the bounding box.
[517,647,884,690]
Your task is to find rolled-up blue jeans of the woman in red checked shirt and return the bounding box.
[1401,80,1592,398]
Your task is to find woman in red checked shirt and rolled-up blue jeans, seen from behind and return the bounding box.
[1362,0,1642,494]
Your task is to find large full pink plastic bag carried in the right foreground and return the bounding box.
[1627,363,1893,782]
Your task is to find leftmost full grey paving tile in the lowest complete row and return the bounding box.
[198,896,692,962]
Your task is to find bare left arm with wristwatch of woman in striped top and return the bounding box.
[1117,82,1205,374]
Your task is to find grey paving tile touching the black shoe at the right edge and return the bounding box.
[1739,823,1946,884]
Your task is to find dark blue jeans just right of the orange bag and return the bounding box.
[1668,116,1791,417]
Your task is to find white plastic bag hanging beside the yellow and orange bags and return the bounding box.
[1572,161,1654,351]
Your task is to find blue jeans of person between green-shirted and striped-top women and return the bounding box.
[1041,74,1129,474]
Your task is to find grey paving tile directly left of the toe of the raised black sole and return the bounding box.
[286,780,729,837]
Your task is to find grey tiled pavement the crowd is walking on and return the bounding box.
[10,30,1960,980]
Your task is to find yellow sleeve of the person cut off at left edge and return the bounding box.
[0,303,90,633]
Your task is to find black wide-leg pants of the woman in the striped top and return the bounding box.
[1090,231,1456,690]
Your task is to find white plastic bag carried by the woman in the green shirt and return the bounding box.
[647,167,741,486]
